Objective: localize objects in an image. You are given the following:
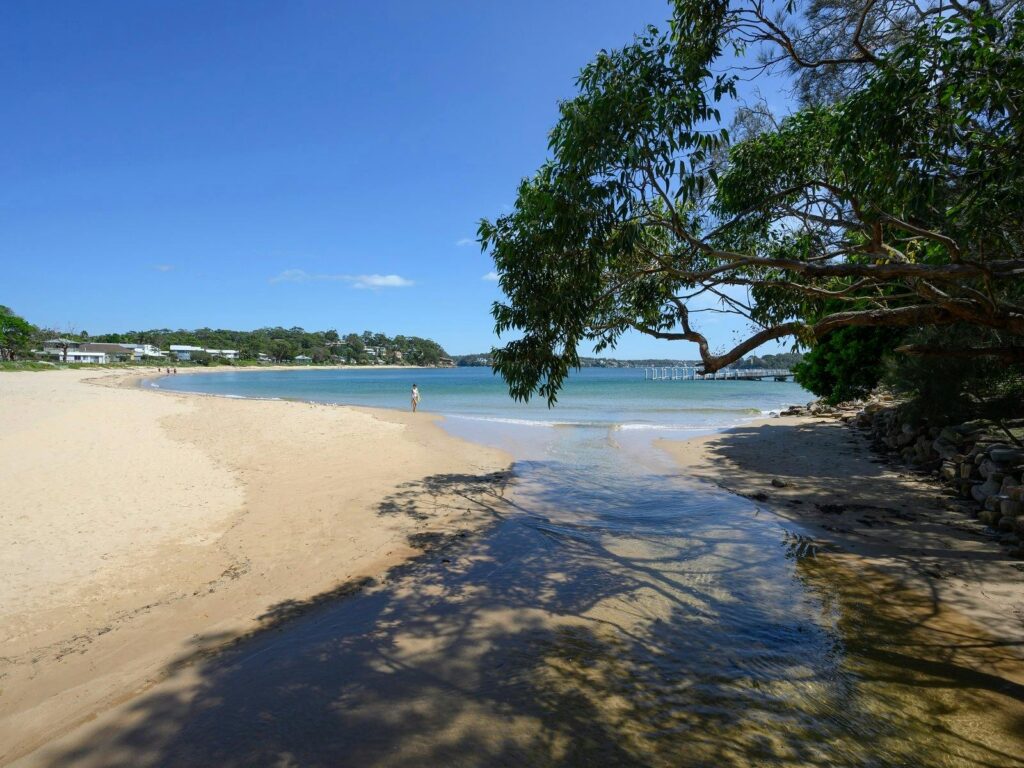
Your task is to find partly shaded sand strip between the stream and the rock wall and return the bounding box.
[659,417,1024,643]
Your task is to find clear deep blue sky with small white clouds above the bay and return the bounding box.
[0,0,790,357]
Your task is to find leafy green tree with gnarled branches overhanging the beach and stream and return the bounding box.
[479,0,1024,401]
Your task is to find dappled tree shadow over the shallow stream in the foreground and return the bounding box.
[36,468,1024,768]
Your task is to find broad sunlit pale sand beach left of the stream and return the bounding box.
[0,370,509,764]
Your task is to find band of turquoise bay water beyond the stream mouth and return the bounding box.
[157,368,812,431]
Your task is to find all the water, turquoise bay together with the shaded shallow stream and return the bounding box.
[128,369,1024,767]
